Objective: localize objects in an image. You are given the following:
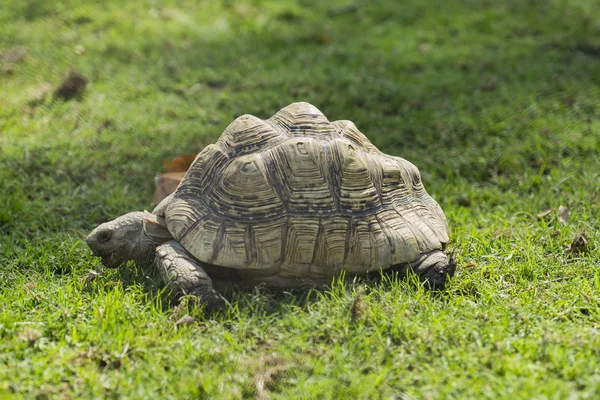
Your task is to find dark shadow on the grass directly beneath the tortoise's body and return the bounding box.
[108,262,462,320]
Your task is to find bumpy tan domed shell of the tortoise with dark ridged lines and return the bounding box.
[161,103,448,278]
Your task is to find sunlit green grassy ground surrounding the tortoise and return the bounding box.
[0,0,600,399]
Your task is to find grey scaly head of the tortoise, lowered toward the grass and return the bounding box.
[85,211,172,268]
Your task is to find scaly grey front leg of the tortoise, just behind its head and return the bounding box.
[154,241,225,309]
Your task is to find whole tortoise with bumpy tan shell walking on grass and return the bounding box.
[86,102,456,306]
